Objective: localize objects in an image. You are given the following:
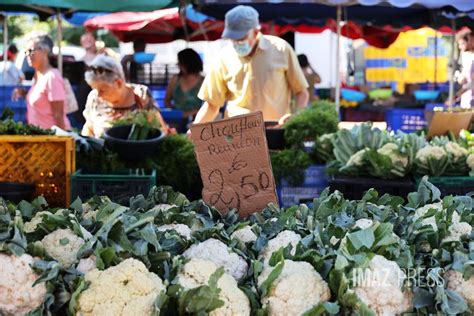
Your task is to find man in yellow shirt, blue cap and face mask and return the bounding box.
[194,6,309,123]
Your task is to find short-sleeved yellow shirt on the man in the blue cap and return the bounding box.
[198,35,308,121]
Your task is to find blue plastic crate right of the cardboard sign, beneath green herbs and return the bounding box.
[277,165,328,207]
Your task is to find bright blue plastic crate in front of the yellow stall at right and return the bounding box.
[385,109,427,133]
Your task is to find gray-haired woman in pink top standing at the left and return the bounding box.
[15,35,71,129]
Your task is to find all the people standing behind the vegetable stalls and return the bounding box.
[6,5,474,137]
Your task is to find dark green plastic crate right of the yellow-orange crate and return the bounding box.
[71,170,156,205]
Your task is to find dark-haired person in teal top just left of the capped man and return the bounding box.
[165,48,204,118]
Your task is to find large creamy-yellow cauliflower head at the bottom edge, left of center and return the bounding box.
[76,258,166,316]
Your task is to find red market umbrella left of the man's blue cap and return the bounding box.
[84,8,224,43]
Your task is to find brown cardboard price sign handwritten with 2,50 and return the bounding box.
[191,112,278,217]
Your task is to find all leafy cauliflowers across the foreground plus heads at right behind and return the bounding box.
[0,178,474,316]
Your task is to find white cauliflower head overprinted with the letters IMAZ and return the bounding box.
[353,255,412,316]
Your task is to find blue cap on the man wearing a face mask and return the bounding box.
[222,5,259,40]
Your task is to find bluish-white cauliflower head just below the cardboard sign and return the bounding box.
[183,238,248,280]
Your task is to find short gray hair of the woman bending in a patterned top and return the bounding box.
[84,54,125,86]
